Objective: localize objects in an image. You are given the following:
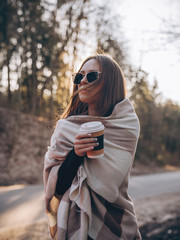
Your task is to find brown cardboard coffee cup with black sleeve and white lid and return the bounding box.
[80,121,104,158]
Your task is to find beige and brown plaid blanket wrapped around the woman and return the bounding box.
[44,98,141,240]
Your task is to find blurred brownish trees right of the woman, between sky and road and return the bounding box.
[131,69,180,165]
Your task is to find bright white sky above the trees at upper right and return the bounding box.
[114,0,180,104]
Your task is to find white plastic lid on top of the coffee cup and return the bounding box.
[80,121,104,133]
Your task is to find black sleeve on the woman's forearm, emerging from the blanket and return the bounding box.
[56,148,84,195]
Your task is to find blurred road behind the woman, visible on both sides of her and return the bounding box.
[0,172,180,240]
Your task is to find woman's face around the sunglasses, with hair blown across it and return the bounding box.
[78,59,102,107]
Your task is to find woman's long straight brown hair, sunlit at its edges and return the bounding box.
[61,54,126,118]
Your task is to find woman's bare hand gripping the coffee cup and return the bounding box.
[74,133,99,157]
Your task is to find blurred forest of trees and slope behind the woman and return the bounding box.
[0,0,180,185]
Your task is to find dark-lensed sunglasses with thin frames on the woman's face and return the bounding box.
[72,71,101,84]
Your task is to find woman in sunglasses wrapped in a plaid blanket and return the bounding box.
[44,55,141,240]
